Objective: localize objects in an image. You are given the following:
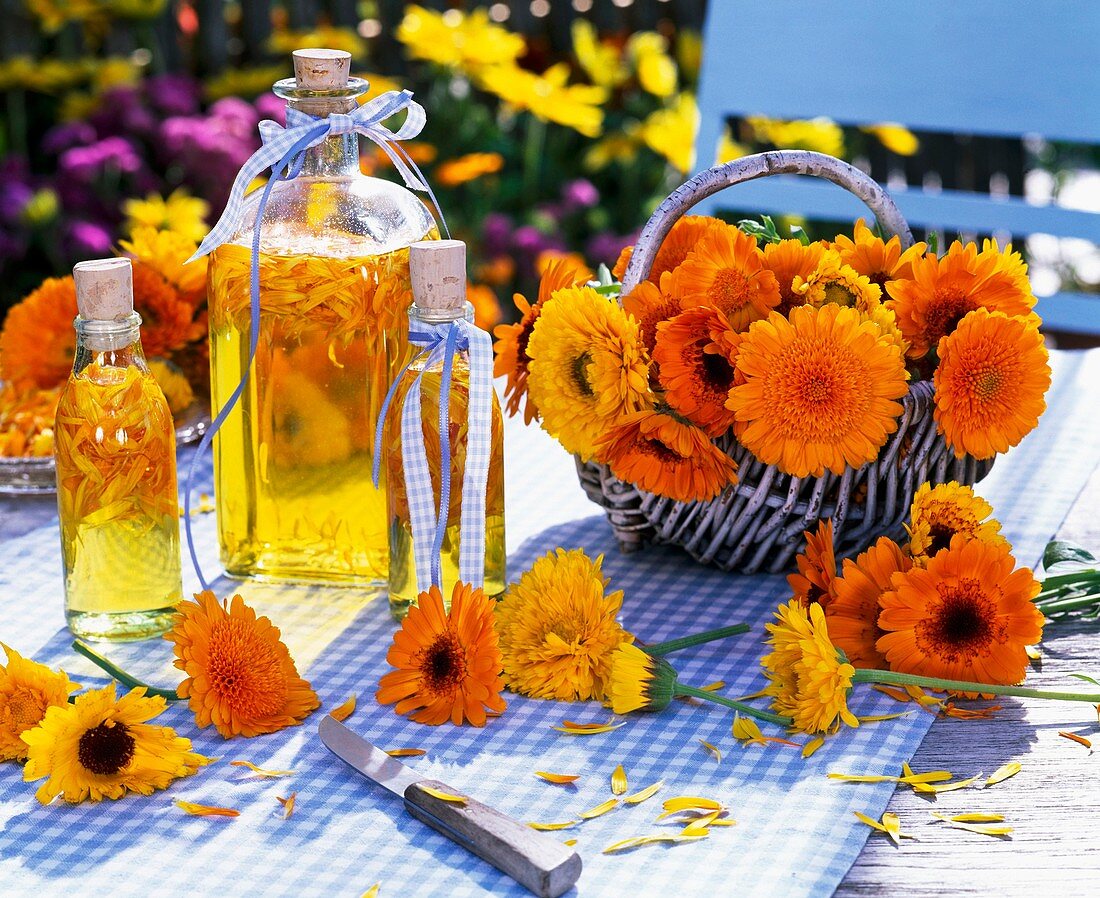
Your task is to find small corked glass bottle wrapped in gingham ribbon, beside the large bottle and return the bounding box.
[383,240,505,620]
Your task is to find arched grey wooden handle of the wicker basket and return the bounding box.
[623,150,913,295]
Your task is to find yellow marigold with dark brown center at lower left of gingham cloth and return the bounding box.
[22,683,210,804]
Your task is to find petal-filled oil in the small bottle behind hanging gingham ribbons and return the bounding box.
[384,357,505,618]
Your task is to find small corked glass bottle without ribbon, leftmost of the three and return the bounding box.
[55,259,183,639]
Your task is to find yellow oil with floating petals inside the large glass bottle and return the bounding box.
[209,238,411,585]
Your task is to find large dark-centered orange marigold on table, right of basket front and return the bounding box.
[877,536,1043,685]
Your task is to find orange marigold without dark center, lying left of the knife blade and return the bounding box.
[164,590,320,738]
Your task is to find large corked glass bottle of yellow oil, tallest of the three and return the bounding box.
[209,51,437,585]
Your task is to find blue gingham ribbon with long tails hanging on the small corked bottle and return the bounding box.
[374,319,493,592]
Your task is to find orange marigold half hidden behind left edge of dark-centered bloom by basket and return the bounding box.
[825,536,913,668]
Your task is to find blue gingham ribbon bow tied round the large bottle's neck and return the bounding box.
[184,90,450,589]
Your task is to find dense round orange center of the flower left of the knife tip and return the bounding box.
[207,617,287,719]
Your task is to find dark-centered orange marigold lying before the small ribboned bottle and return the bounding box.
[377,583,507,726]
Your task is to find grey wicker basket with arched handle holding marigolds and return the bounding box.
[578,151,992,573]
